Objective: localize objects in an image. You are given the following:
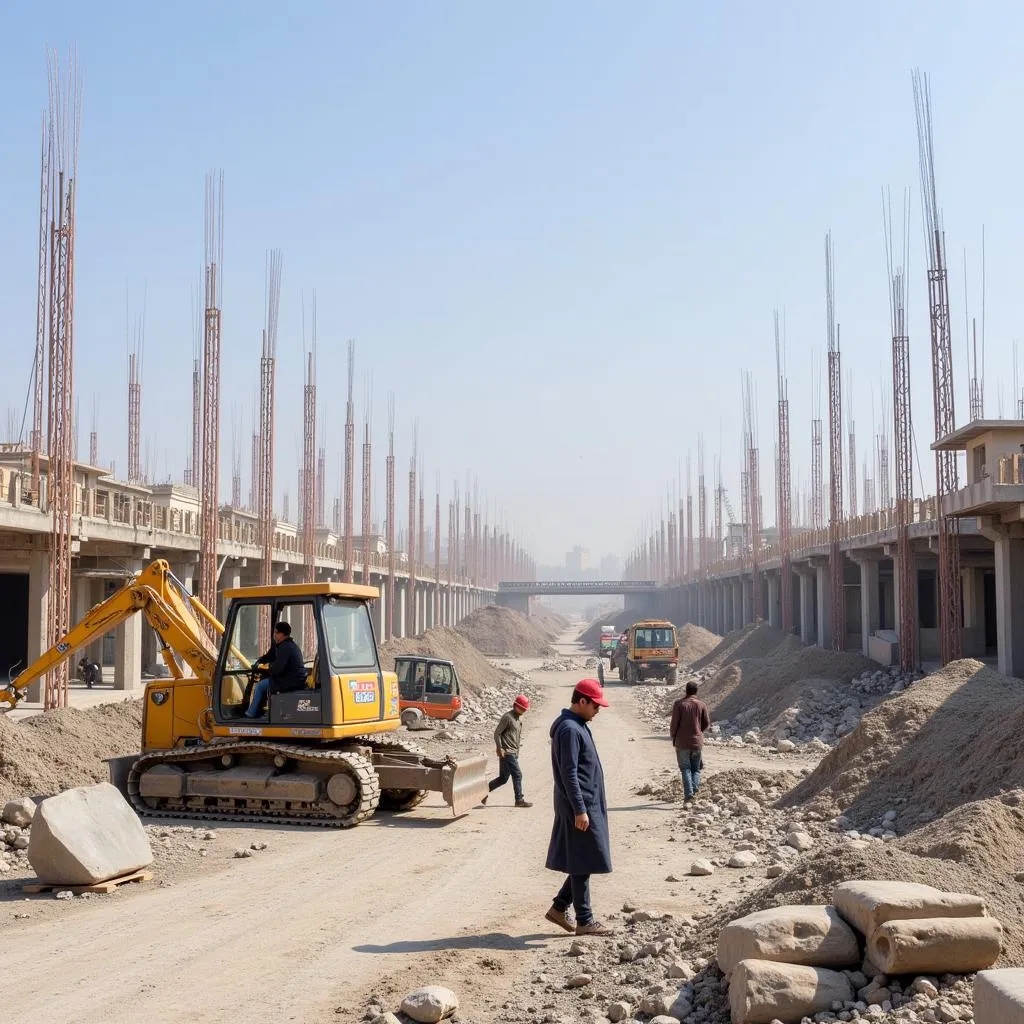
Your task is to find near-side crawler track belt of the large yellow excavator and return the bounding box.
[127,737,381,828]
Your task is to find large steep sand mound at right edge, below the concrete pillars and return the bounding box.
[787,659,1024,828]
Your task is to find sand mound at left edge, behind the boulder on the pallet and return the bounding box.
[0,699,142,801]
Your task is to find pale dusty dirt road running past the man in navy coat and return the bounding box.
[0,648,815,1024]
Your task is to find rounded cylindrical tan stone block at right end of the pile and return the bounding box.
[867,918,1002,974]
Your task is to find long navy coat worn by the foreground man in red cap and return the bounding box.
[546,709,611,874]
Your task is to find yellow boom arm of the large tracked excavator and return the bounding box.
[0,559,224,707]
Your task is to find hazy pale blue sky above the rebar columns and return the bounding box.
[0,0,1024,562]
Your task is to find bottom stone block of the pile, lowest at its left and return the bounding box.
[729,959,854,1024]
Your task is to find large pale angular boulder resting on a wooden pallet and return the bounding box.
[29,782,153,886]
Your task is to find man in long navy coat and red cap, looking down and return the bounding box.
[545,679,613,935]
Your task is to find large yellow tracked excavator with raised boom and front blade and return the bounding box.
[0,559,487,828]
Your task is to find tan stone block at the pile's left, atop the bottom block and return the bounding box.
[718,906,860,976]
